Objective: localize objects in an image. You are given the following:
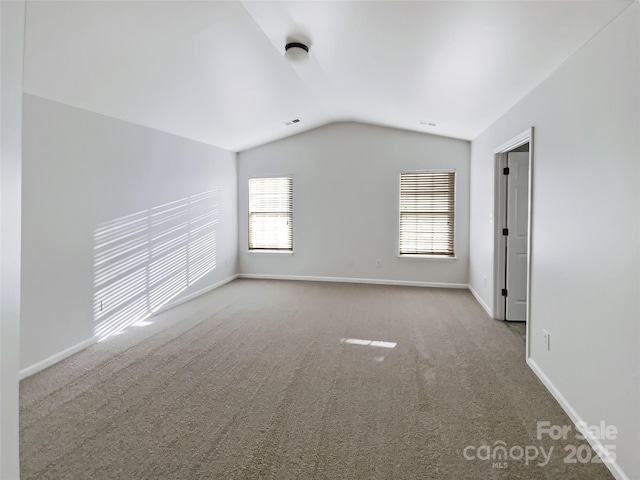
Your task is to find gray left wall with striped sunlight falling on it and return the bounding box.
[21,95,238,369]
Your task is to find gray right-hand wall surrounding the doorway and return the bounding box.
[470,3,640,478]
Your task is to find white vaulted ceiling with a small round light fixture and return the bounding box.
[24,0,631,151]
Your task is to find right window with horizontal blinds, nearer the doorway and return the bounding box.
[400,170,456,257]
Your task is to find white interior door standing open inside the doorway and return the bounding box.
[505,152,529,321]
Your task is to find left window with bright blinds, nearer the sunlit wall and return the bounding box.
[249,177,293,251]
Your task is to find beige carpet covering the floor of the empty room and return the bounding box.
[20,280,613,480]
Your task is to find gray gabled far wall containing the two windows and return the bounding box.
[238,122,469,285]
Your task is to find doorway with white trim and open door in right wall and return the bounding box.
[494,128,533,357]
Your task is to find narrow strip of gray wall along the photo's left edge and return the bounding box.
[0,1,25,479]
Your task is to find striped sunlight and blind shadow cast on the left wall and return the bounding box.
[93,186,219,341]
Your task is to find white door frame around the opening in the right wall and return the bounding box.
[493,127,534,358]
